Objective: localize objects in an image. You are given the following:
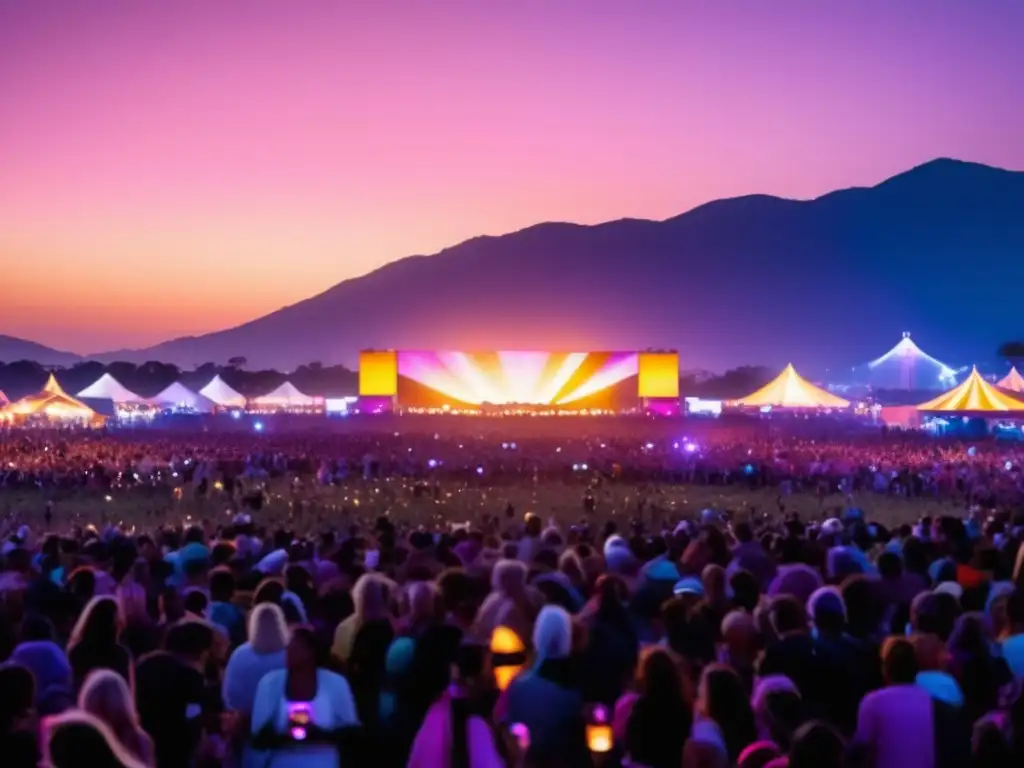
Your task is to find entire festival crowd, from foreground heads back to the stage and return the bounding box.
[0,420,1024,768]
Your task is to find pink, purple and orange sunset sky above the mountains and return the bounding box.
[0,0,1024,353]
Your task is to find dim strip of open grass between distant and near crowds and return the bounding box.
[0,478,965,532]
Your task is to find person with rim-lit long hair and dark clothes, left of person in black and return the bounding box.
[68,596,133,691]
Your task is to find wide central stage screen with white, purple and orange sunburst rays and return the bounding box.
[398,351,639,411]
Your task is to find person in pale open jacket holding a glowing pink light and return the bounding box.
[251,627,359,768]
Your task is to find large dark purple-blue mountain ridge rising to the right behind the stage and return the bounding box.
[90,160,1024,370]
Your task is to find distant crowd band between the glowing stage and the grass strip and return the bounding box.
[0,417,1024,502]
